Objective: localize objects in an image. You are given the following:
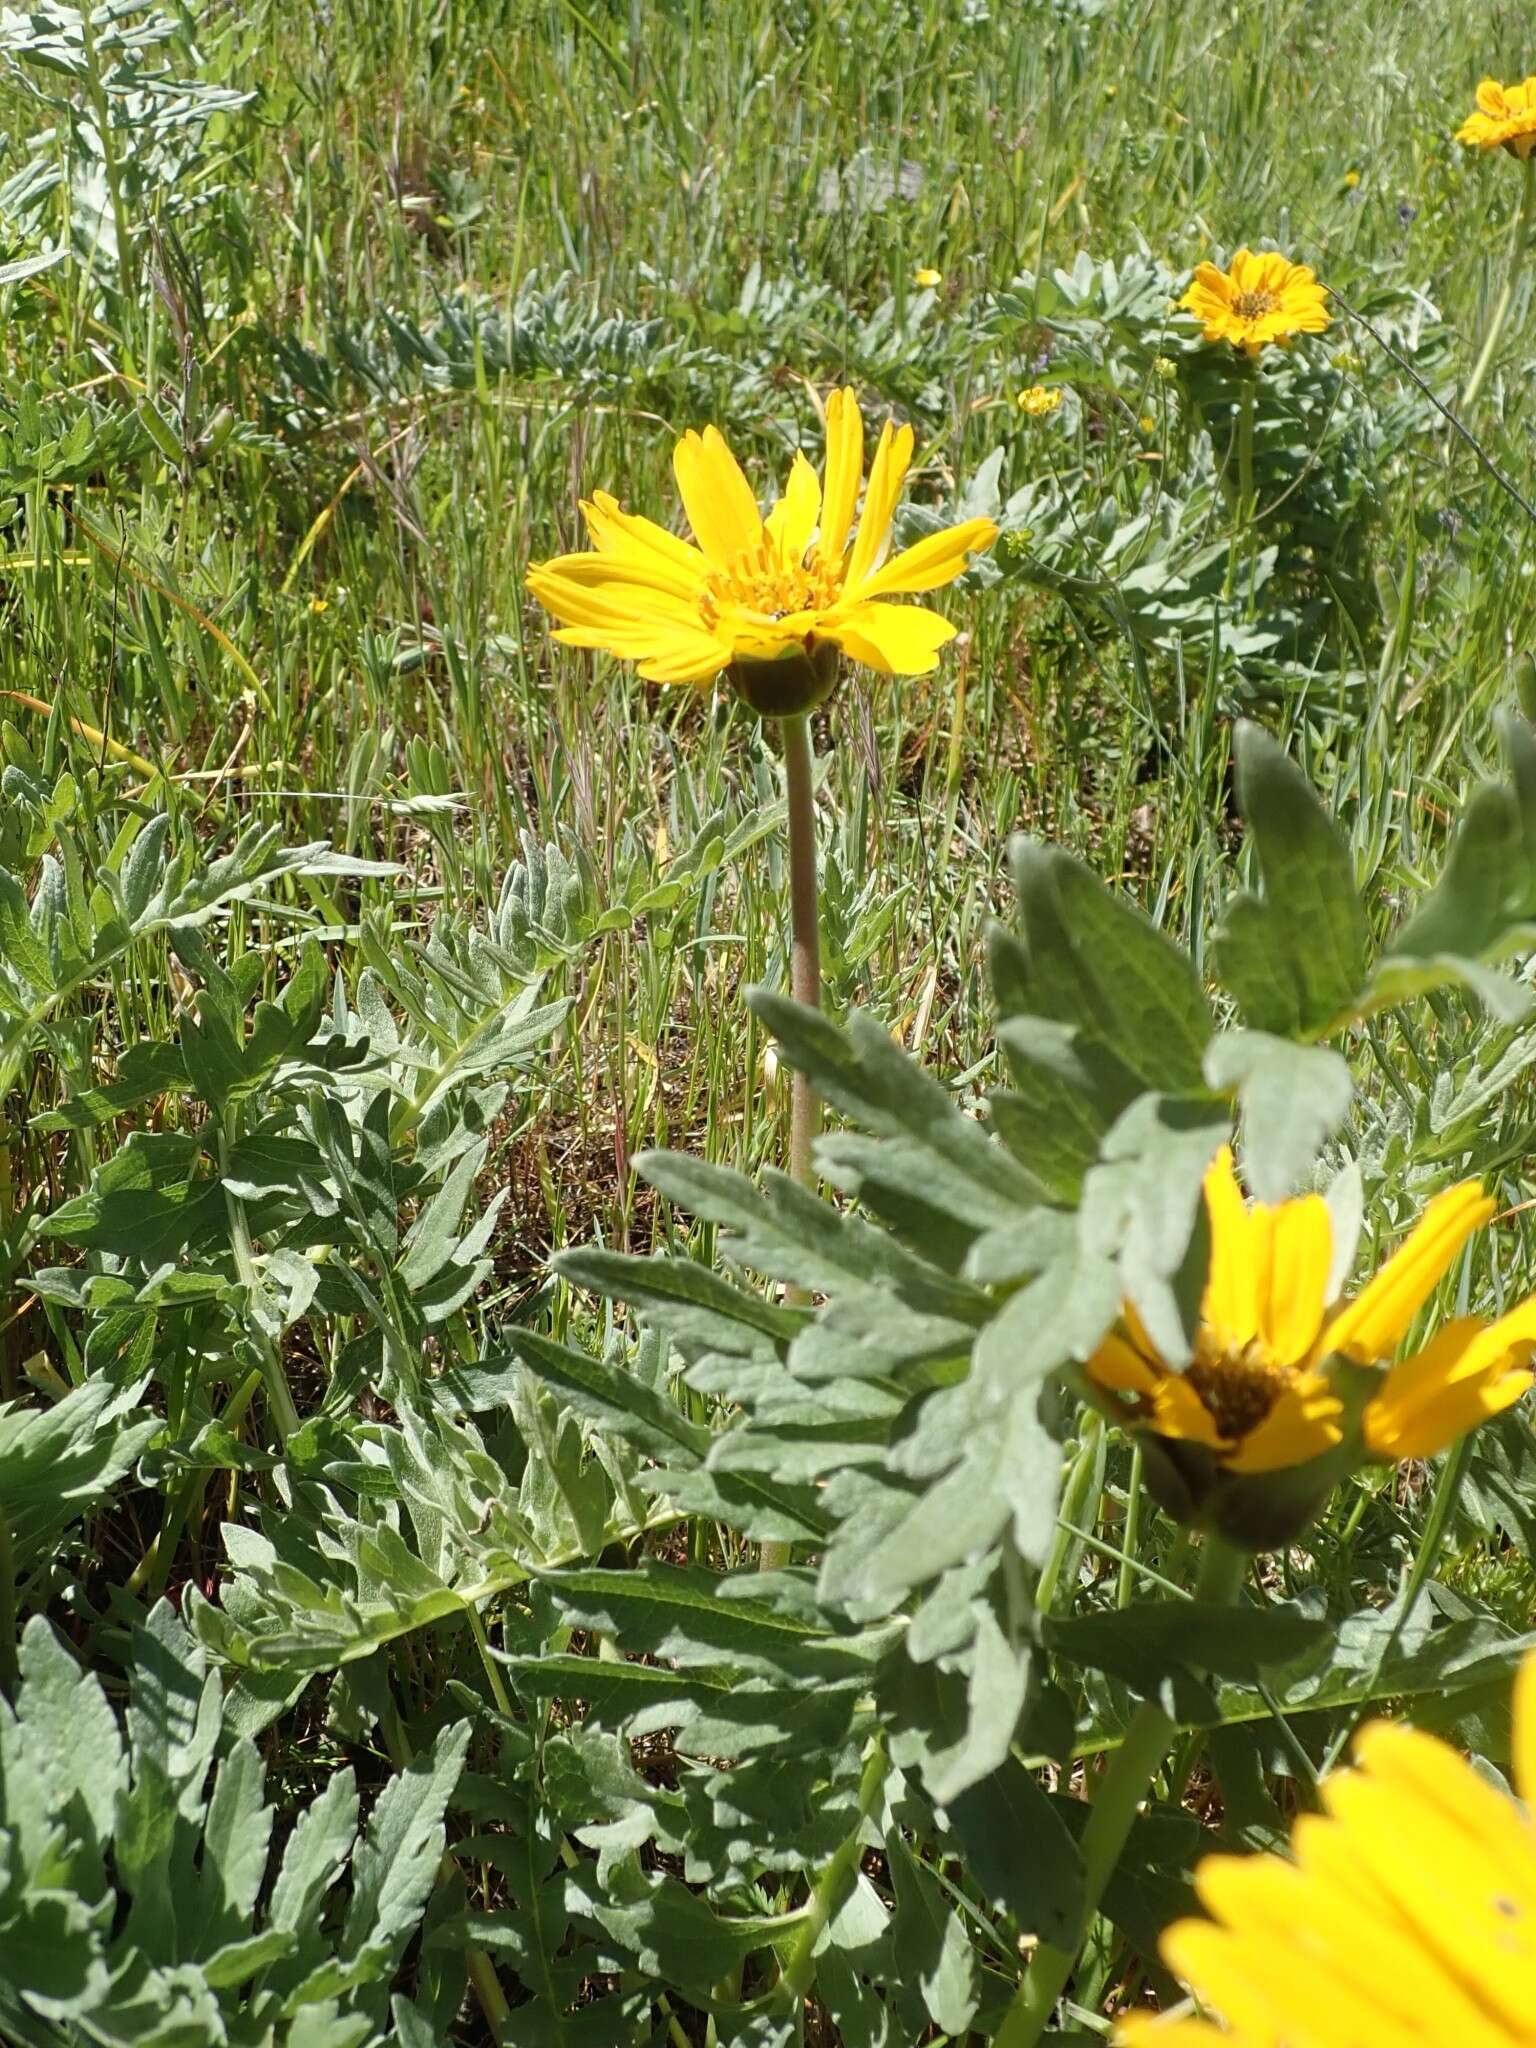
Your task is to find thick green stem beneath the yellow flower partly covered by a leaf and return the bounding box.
[993,1536,1247,2048]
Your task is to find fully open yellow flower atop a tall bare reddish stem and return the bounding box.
[528,391,997,713]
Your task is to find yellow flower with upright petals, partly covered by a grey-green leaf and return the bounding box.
[1087,1147,1536,1473]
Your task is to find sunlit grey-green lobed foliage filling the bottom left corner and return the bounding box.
[0,1602,469,2048]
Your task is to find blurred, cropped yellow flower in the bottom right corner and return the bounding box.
[1116,1657,1536,2048]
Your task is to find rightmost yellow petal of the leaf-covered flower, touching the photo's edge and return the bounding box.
[1362,1300,1536,1458]
